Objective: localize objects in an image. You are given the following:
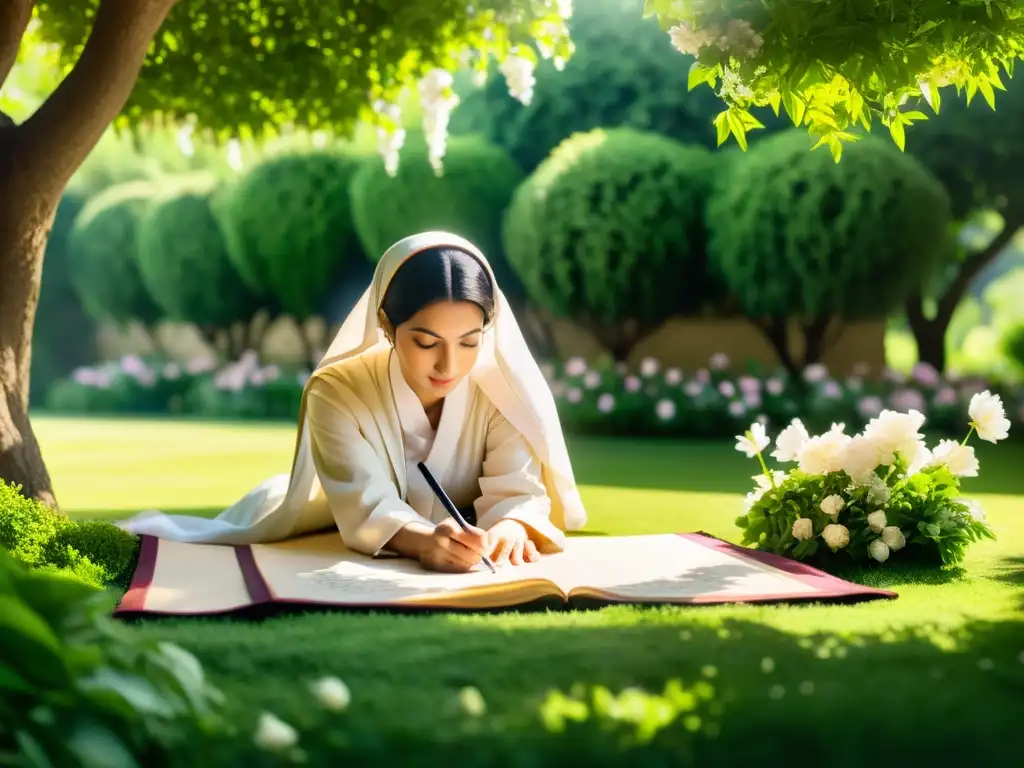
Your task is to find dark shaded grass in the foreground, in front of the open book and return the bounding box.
[128,608,1024,768]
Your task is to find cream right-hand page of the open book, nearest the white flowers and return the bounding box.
[537,534,816,601]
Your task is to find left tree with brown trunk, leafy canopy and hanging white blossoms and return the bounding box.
[0,0,571,505]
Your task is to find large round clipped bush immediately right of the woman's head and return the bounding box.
[504,128,715,359]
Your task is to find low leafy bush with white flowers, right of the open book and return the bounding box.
[736,391,1011,567]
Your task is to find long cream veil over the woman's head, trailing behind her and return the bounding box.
[121,231,587,544]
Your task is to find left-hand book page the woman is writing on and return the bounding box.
[251,534,558,604]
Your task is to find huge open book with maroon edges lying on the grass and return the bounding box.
[117,531,896,614]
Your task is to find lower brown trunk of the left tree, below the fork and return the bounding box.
[0,196,56,508]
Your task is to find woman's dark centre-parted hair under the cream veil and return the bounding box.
[381,248,495,328]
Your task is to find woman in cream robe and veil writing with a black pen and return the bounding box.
[123,232,587,572]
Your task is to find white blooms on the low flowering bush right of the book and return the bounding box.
[736,391,1010,562]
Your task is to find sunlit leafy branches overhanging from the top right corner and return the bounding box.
[644,0,1024,162]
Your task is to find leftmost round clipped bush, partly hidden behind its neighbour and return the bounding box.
[68,181,161,327]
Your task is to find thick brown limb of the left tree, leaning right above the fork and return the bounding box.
[9,0,177,201]
